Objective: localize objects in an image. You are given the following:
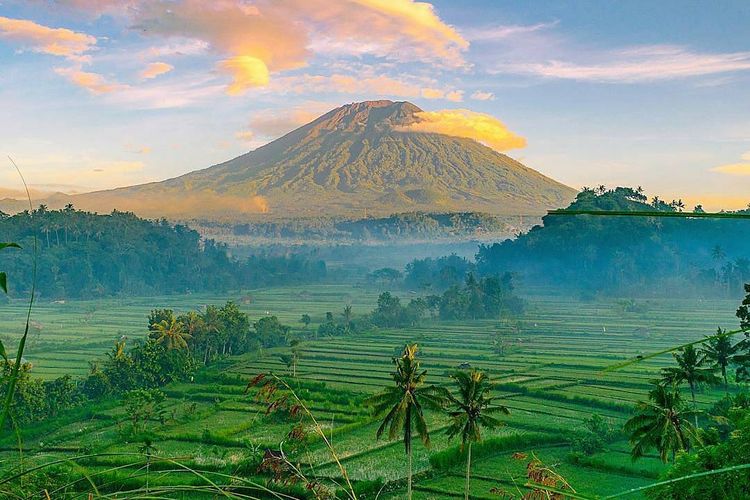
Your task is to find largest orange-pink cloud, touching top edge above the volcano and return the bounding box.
[53,0,469,95]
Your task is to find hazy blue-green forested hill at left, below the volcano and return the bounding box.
[0,206,326,299]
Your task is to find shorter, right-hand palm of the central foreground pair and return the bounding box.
[446,370,510,500]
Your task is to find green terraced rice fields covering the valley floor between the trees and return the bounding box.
[0,285,736,498]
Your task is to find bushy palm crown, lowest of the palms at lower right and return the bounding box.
[623,384,696,462]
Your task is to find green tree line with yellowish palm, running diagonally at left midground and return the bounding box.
[0,302,290,425]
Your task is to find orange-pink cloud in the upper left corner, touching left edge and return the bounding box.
[0,16,96,60]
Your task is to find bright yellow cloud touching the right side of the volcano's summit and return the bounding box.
[398,109,526,151]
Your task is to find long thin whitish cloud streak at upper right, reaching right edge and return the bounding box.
[496,45,750,83]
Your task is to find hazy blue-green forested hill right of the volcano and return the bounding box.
[477,187,750,294]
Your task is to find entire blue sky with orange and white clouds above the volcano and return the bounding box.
[0,0,750,209]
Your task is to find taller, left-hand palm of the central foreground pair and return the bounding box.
[366,344,448,499]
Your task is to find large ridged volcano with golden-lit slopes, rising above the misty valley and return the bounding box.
[73,101,575,217]
